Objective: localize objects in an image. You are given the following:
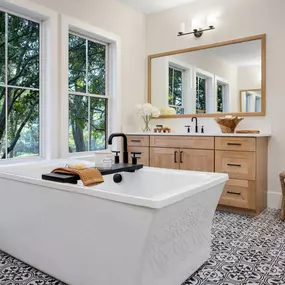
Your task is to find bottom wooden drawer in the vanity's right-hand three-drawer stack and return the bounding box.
[219,179,256,210]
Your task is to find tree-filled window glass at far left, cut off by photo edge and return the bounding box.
[0,11,40,159]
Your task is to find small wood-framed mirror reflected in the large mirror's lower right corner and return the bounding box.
[240,89,261,113]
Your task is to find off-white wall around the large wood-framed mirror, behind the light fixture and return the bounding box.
[146,0,285,207]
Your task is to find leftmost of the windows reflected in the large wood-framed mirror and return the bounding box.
[168,66,184,114]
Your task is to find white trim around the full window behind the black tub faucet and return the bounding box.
[59,15,122,158]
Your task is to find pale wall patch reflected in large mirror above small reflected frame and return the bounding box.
[238,65,261,90]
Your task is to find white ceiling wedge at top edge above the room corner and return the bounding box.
[119,0,197,14]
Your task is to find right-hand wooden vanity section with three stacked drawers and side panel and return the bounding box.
[215,137,268,215]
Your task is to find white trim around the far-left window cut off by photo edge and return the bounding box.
[0,0,59,164]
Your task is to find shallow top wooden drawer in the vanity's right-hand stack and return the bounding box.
[215,137,255,151]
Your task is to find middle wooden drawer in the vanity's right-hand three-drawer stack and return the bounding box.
[215,150,256,180]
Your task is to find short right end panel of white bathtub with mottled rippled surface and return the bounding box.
[142,183,225,285]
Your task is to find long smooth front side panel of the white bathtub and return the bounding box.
[0,178,154,285]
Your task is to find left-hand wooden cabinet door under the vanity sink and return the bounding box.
[149,147,180,169]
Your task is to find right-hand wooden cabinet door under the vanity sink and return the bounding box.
[179,149,214,172]
